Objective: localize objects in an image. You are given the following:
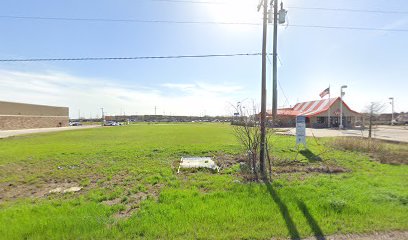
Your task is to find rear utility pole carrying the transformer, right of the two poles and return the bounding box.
[272,0,283,124]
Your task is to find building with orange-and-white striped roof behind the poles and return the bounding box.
[267,97,361,128]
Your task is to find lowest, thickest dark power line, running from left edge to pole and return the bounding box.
[0,53,262,62]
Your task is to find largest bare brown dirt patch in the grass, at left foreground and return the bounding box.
[0,165,164,218]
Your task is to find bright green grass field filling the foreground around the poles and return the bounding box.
[0,124,408,239]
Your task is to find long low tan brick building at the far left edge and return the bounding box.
[0,101,69,130]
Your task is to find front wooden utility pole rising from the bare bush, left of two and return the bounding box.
[259,0,268,175]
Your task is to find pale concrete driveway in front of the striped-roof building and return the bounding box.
[280,126,408,142]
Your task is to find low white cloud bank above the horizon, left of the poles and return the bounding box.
[0,70,242,117]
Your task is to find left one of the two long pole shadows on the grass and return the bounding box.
[264,179,300,239]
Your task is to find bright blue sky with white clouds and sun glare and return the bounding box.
[0,0,408,118]
